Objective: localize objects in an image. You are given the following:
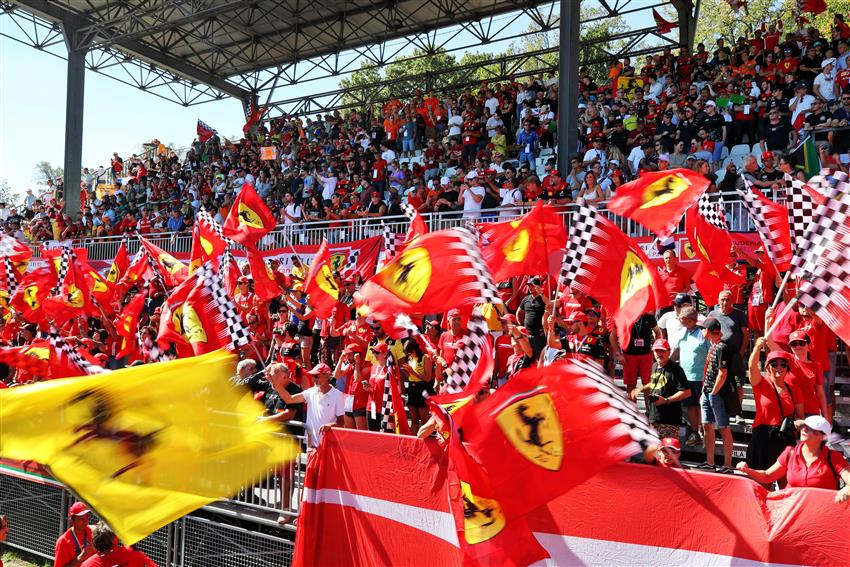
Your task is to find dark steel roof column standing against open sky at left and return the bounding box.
[62,22,87,219]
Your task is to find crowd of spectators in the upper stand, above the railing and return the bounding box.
[0,15,850,241]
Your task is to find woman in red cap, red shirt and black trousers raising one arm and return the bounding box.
[747,337,803,478]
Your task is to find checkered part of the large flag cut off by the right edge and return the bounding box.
[791,172,850,277]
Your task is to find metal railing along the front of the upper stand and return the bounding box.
[30,193,754,260]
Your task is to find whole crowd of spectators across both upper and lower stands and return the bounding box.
[0,16,850,496]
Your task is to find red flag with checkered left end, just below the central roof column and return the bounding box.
[561,206,665,345]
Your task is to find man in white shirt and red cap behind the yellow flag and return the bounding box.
[278,362,345,447]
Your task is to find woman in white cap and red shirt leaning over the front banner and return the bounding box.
[738,415,850,503]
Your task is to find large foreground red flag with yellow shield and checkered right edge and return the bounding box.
[463,359,659,518]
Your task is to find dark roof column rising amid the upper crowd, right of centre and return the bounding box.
[558,0,581,175]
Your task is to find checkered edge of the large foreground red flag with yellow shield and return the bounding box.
[570,358,661,453]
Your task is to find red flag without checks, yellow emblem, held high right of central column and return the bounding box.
[608,168,709,240]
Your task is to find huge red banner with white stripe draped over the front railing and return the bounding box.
[294,429,850,566]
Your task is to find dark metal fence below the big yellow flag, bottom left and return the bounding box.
[0,430,307,567]
